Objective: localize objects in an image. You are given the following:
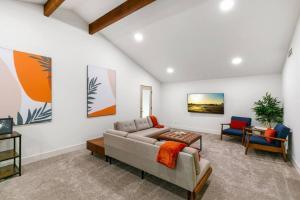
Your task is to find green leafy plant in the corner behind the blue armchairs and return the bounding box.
[253,93,283,128]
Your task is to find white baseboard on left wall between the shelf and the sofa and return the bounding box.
[22,143,86,165]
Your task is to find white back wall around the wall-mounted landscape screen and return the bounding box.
[161,75,281,133]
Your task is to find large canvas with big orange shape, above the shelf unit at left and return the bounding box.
[0,48,52,125]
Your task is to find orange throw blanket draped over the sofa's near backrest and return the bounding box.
[156,141,187,169]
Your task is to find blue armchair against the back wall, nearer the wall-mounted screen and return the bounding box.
[221,116,252,144]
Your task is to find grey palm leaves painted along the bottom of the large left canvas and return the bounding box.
[15,103,52,125]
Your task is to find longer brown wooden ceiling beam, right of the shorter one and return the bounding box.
[89,0,155,34]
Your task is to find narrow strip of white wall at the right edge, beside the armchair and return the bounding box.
[282,16,300,169]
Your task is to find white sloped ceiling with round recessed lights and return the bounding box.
[17,0,300,82]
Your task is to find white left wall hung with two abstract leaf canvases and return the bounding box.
[0,0,160,162]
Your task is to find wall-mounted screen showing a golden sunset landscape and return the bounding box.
[188,93,224,114]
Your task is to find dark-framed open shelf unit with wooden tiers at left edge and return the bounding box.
[0,131,22,180]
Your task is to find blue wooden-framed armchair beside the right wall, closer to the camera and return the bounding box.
[245,124,290,161]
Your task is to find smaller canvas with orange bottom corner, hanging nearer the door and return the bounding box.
[87,65,116,117]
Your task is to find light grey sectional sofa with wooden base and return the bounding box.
[104,118,212,199]
